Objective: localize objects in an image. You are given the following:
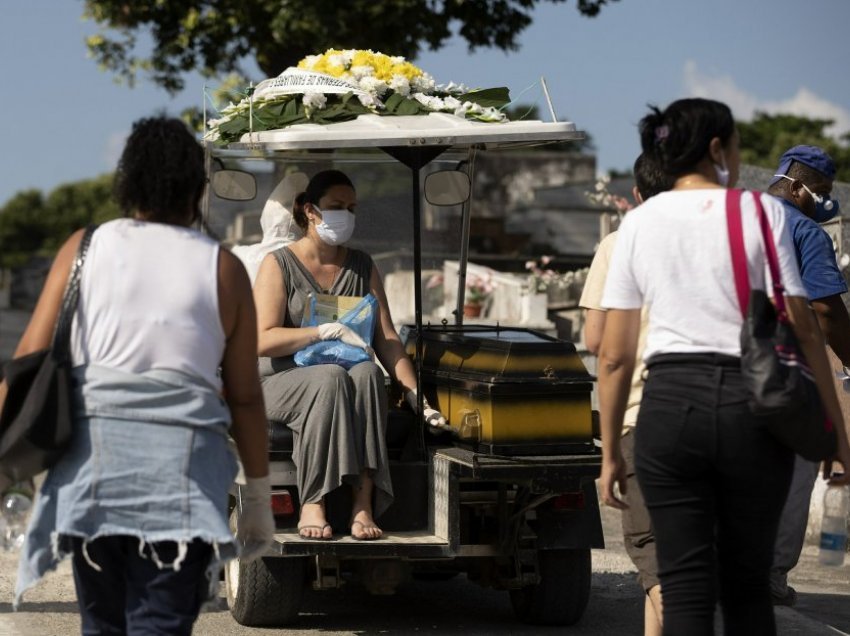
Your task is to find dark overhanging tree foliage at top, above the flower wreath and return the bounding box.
[84,0,618,93]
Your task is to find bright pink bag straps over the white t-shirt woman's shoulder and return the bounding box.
[726,189,788,322]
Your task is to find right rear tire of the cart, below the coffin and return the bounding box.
[510,548,591,625]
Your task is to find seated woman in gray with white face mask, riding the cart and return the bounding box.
[254,170,445,540]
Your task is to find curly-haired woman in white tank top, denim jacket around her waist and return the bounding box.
[5,117,273,634]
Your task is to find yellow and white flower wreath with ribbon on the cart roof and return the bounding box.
[208,49,510,143]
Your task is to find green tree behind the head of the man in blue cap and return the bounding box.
[738,113,850,181]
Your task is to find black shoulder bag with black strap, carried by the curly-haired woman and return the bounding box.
[0,225,97,481]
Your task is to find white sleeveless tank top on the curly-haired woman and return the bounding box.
[71,219,225,390]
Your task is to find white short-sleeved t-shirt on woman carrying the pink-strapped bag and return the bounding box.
[602,188,806,360]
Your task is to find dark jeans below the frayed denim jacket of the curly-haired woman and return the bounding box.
[73,536,212,636]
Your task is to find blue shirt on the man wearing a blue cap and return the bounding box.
[779,199,847,300]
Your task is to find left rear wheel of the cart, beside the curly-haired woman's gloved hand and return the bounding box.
[224,510,307,627]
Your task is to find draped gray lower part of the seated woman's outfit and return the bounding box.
[262,362,393,517]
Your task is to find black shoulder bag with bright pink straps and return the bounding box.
[726,190,838,461]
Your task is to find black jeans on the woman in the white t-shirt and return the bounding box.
[635,354,794,636]
